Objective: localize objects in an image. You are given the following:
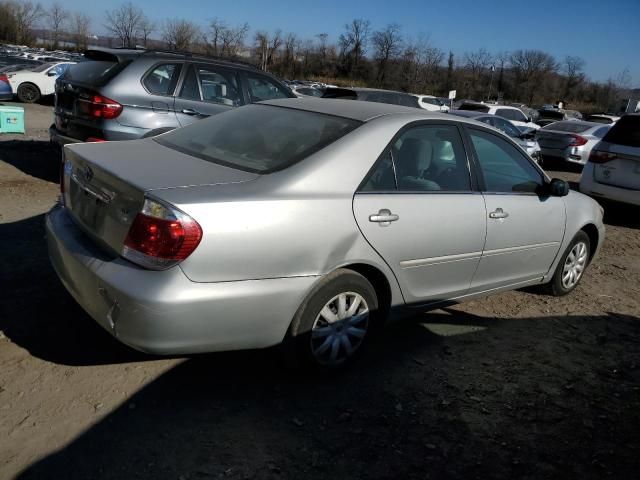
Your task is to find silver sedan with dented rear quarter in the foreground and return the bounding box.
[46,99,604,368]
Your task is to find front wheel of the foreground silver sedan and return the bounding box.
[547,230,591,297]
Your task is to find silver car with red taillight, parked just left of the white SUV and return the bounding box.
[536,120,611,165]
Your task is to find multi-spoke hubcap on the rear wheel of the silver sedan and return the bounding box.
[311,292,369,366]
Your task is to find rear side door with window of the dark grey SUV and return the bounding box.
[175,63,244,126]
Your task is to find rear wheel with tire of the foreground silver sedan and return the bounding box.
[283,269,378,372]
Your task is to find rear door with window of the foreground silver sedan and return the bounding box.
[353,124,486,304]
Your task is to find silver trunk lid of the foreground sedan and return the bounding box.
[63,139,259,255]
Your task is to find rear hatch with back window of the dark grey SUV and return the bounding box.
[54,50,140,141]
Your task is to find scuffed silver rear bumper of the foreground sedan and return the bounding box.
[46,206,317,354]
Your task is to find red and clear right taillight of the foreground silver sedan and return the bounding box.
[122,199,202,270]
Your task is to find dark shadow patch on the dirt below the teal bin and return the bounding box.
[0,140,60,183]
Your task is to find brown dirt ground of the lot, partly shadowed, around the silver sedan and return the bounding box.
[0,101,640,480]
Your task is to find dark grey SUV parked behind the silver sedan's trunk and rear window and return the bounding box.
[49,49,295,145]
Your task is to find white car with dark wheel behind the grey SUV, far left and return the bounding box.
[7,62,75,103]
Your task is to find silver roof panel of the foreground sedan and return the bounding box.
[260,98,450,122]
